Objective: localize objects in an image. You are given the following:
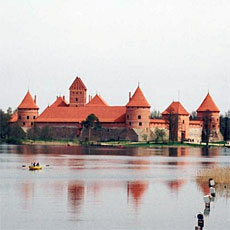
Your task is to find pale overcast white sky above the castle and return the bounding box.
[0,0,230,113]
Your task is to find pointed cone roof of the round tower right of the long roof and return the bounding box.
[126,86,151,108]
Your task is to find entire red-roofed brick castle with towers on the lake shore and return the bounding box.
[10,77,222,143]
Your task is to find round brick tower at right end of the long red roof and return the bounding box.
[126,86,151,129]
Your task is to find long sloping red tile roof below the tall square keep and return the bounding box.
[36,106,126,122]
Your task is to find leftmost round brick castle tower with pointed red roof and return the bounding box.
[17,91,39,129]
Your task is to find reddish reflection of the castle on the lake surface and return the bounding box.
[12,146,229,213]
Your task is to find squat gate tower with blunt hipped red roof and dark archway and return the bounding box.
[162,101,189,141]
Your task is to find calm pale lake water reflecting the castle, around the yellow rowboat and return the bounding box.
[0,145,230,230]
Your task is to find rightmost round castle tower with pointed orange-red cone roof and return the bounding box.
[197,93,223,141]
